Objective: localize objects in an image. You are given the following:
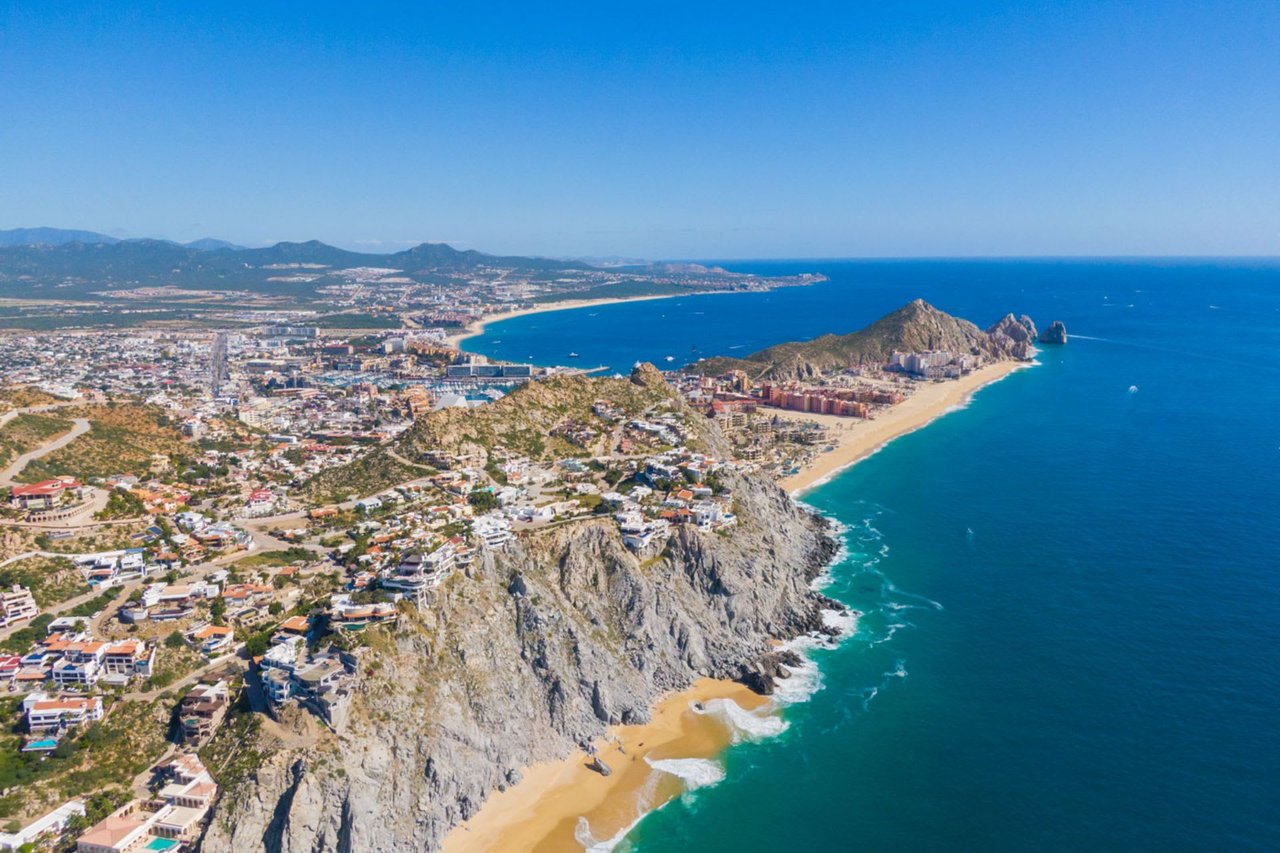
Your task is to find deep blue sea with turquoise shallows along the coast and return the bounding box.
[470,260,1280,853]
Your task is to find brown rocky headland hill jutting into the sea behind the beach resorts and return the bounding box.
[686,300,1036,378]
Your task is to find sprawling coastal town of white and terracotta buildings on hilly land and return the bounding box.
[0,286,980,853]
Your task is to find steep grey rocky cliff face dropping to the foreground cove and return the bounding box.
[204,478,835,853]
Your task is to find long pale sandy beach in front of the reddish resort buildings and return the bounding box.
[760,361,1028,494]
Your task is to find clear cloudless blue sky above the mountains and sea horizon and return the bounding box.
[0,0,1280,257]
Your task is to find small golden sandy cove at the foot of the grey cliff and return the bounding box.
[442,679,768,853]
